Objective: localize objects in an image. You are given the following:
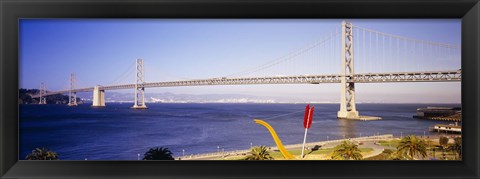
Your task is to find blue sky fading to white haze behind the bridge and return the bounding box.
[20,19,461,102]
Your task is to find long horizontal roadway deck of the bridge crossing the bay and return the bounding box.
[32,70,462,98]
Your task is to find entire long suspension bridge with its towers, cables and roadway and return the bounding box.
[32,21,462,119]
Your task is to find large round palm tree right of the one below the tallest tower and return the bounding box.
[397,135,427,159]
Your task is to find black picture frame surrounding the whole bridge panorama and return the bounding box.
[0,0,480,179]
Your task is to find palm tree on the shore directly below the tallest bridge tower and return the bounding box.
[331,140,363,160]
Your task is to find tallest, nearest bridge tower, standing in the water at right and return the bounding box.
[337,21,359,119]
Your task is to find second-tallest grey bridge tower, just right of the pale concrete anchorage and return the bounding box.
[132,58,147,109]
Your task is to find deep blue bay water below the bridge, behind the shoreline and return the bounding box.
[19,103,460,160]
